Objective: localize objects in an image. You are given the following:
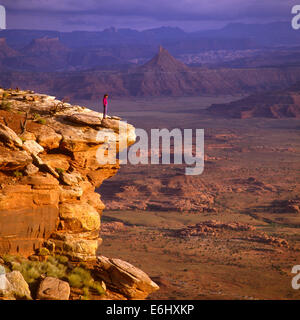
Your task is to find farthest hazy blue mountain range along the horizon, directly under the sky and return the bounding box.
[0,22,300,49]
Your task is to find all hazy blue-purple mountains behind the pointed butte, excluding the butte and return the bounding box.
[0,22,300,72]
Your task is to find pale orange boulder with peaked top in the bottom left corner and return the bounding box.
[0,271,32,300]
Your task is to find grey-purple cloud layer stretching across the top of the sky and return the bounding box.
[1,0,295,31]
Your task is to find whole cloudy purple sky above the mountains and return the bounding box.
[0,0,300,31]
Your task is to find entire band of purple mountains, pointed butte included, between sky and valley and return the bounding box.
[0,22,300,99]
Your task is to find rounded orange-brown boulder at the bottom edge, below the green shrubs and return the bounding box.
[37,277,70,300]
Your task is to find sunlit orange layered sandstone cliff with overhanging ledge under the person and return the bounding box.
[0,89,135,261]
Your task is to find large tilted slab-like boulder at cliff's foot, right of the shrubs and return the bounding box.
[95,256,159,300]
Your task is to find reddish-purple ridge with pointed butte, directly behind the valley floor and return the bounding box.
[0,46,300,100]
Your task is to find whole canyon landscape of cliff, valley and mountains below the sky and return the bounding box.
[0,24,300,300]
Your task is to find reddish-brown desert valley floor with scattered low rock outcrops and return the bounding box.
[79,96,300,299]
